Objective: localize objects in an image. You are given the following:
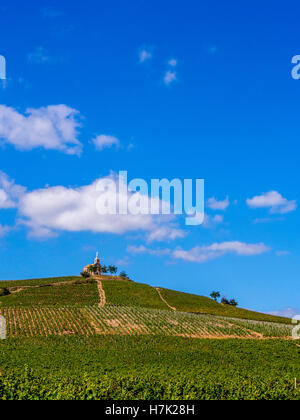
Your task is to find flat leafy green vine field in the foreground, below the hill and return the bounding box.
[0,336,300,400]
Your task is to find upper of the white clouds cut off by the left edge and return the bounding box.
[0,105,82,155]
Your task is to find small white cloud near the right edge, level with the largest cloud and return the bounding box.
[247,191,297,214]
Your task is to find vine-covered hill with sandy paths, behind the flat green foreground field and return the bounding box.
[0,276,292,338]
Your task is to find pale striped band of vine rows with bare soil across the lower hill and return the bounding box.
[0,305,291,338]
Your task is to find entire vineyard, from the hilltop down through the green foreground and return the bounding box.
[0,276,300,399]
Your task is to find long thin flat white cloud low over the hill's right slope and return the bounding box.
[172,241,270,263]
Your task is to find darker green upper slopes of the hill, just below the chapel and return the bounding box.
[0,276,290,324]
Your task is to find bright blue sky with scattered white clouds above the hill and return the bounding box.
[0,0,300,312]
